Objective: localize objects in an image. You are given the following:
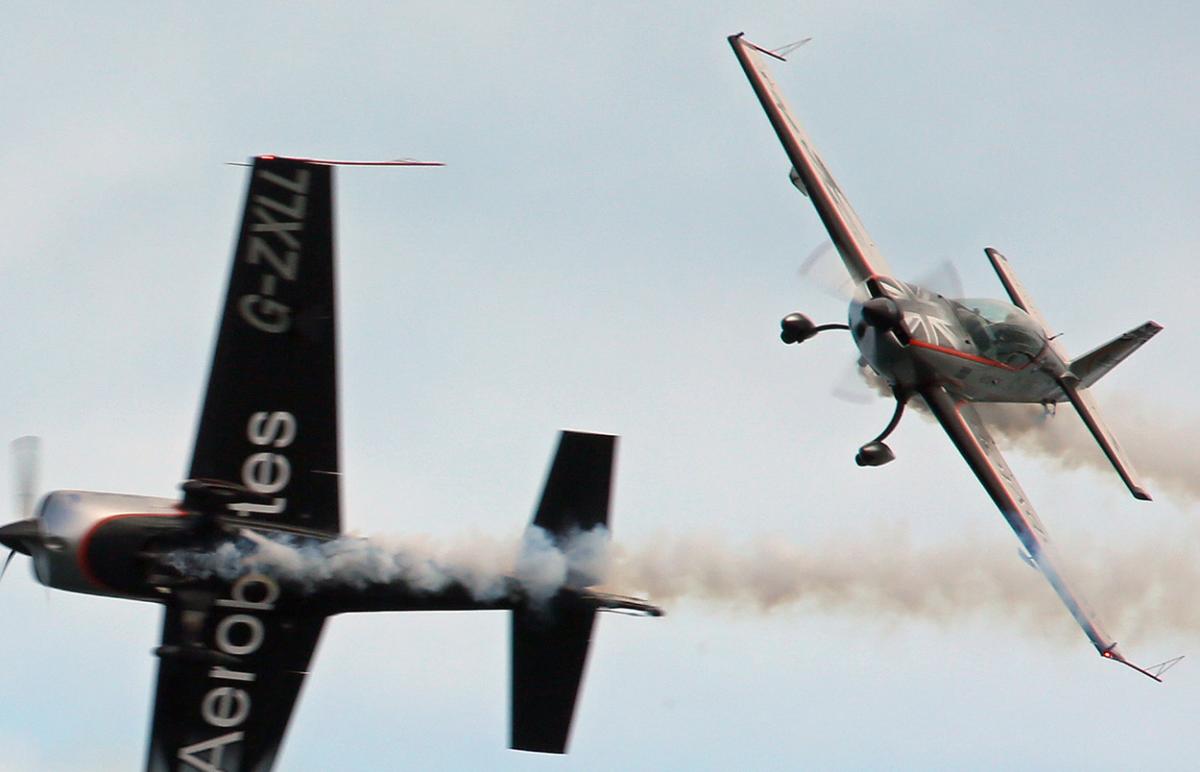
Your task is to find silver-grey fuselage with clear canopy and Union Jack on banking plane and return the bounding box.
[850,276,1067,403]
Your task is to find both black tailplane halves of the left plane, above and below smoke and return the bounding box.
[511,431,617,753]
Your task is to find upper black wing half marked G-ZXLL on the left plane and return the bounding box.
[185,157,340,532]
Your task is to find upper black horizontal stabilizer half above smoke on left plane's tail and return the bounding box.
[533,431,617,543]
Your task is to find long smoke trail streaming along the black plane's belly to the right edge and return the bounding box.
[170,527,1200,641]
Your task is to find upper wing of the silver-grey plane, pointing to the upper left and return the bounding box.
[728,32,892,283]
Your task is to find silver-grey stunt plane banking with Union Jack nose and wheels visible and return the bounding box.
[728,32,1181,681]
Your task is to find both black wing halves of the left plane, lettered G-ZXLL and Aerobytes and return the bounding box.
[146,156,340,772]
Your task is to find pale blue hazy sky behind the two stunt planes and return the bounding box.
[0,1,1200,772]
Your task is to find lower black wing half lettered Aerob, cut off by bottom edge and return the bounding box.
[146,605,325,772]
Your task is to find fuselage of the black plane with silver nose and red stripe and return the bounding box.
[31,491,573,616]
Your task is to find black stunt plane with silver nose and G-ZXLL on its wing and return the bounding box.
[0,156,662,772]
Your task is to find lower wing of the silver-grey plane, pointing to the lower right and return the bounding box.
[920,387,1175,681]
